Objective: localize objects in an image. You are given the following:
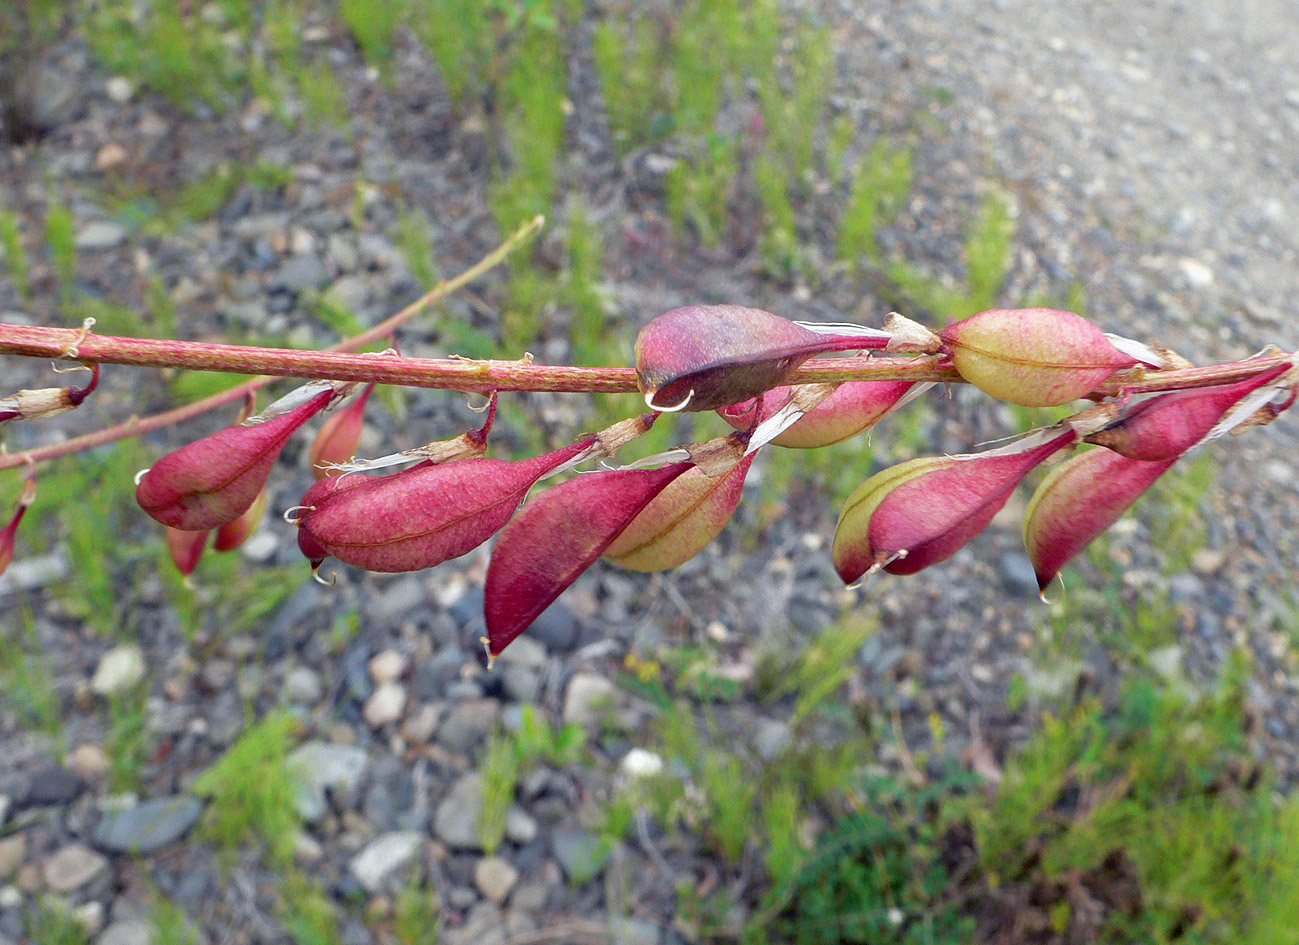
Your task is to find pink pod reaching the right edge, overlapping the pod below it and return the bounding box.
[1086,363,1291,463]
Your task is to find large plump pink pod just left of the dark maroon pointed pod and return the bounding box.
[297,437,596,572]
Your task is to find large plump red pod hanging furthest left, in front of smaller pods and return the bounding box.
[135,390,334,532]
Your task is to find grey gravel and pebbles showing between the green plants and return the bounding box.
[0,0,1299,945]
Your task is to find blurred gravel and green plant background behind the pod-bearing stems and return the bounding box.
[0,0,1299,945]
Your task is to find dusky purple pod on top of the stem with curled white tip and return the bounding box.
[635,305,890,411]
